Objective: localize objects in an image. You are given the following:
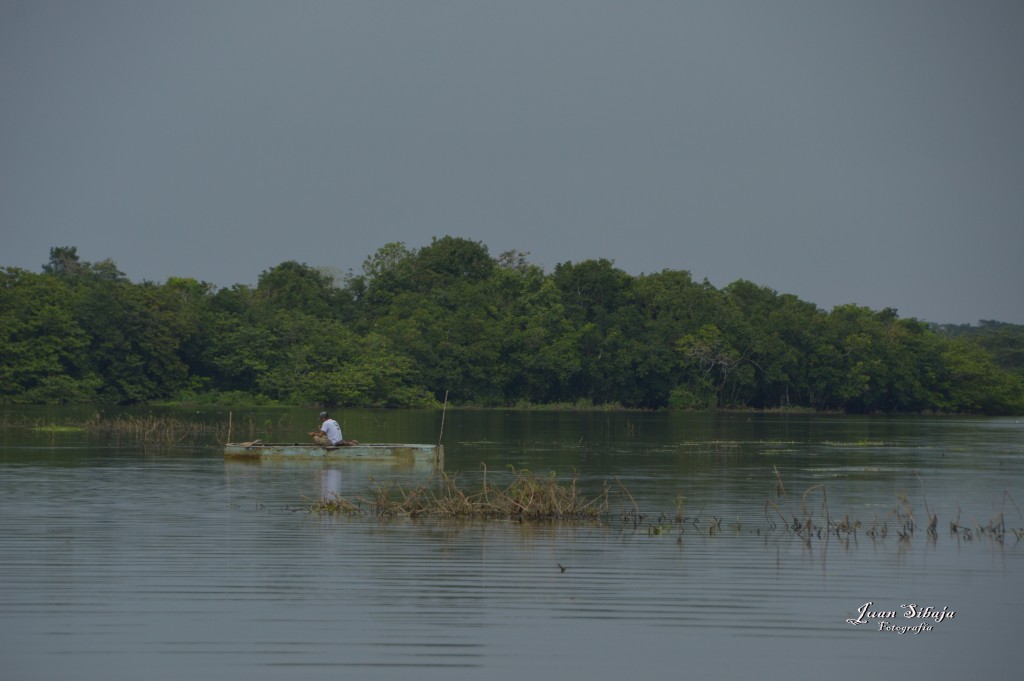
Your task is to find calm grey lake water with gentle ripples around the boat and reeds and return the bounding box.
[0,408,1024,681]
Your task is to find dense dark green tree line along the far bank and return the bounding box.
[0,241,1024,414]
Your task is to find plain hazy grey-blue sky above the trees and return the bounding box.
[0,0,1024,324]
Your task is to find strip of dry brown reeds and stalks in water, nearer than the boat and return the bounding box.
[302,468,1024,548]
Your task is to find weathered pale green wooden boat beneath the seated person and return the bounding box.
[224,440,444,466]
